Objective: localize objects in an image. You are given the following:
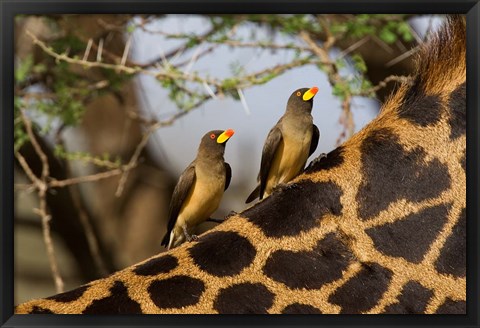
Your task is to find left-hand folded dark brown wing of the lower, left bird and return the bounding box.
[162,161,196,246]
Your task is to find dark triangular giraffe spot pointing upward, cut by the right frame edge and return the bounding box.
[435,208,467,277]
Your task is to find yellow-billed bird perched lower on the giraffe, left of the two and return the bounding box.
[162,129,234,249]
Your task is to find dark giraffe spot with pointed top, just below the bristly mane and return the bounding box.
[398,78,442,127]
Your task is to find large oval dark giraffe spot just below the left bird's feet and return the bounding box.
[189,231,256,277]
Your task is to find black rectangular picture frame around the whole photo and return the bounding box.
[0,0,480,327]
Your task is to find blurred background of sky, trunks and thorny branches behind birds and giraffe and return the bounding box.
[14,14,442,303]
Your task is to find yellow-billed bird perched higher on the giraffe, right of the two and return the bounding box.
[245,87,320,203]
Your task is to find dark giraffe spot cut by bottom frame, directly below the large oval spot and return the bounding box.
[213,283,274,314]
